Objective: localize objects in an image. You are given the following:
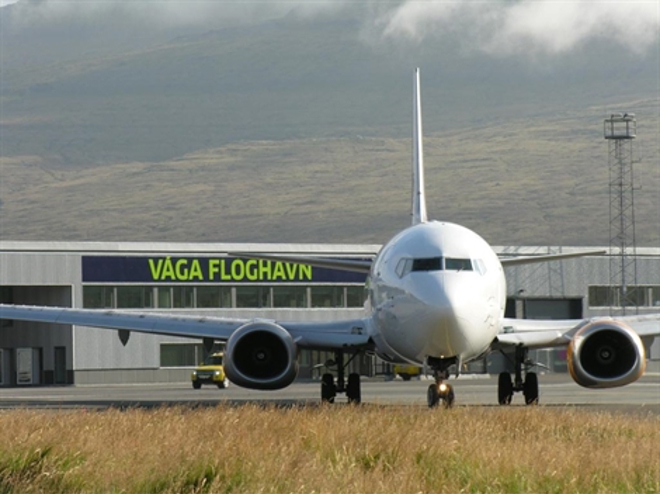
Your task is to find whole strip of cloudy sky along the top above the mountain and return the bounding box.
[5,0,660,56]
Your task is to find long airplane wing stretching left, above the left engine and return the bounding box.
[0,304,369,350]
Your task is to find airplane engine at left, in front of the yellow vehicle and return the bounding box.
[224,321,298,389]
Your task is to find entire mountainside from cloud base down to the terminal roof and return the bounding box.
[0,0,660,245]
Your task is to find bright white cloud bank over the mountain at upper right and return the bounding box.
[375,0,660,55]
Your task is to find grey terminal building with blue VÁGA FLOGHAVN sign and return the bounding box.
[0,241,660,387]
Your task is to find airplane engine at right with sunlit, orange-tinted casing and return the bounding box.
[567,319,646,388]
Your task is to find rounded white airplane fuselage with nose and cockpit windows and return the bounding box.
[369,221,506,365]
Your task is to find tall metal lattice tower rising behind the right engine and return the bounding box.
[604,113,638,315]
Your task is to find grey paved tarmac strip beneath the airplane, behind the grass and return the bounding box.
[0,374,660,415]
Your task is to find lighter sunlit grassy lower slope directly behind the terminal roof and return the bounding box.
[0,102,660,246]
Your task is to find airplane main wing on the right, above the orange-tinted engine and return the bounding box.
[493,314,660,349]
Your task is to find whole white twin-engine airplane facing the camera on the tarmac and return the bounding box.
[0,69,660,407]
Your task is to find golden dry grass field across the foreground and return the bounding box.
[0,406,660,494]
